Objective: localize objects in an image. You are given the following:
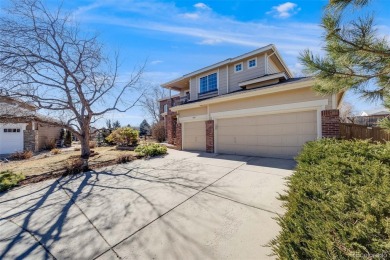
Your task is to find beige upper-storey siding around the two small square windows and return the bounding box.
[229,54,265,92]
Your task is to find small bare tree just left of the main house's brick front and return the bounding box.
[140,85,168,124]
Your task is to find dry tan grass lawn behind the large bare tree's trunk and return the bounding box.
[0,147,135,176]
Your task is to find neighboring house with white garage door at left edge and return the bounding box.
[0,96,61,154]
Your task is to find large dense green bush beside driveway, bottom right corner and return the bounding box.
[270,139,390,259]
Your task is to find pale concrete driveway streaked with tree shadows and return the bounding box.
[0,150,294,259]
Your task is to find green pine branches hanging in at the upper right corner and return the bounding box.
[300,0,390,130]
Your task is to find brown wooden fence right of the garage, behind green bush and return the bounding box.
[340,123,390,143]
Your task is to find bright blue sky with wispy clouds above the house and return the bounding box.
[59,0,390,126]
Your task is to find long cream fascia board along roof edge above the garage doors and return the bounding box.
[171,79,314,112]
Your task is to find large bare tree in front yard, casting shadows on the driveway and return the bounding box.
[0,0,143,168]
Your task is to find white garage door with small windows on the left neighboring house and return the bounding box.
[0,124,25,154]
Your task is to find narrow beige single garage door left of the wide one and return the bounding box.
[183,121,206,151]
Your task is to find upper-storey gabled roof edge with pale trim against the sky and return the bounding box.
[161,44,293,87]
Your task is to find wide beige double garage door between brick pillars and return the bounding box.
[217,111,317,158]
